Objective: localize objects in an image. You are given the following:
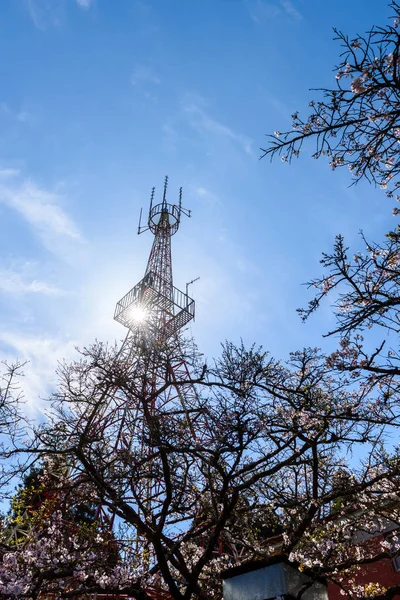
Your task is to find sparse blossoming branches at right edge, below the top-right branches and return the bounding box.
[299,227,400,424]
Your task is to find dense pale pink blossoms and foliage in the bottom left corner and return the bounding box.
[0,457,133,599]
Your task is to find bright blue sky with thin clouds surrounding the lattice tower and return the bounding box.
[0,0,394,407]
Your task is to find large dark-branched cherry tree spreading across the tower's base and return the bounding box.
[0,336,400,600]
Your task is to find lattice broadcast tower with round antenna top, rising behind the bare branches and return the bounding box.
[110,177,196,507]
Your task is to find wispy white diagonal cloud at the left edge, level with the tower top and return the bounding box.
[0,176,82,251]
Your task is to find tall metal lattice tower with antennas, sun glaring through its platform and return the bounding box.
[91,177,198,567]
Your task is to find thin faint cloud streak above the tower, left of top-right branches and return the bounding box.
[182,99,253,154]
